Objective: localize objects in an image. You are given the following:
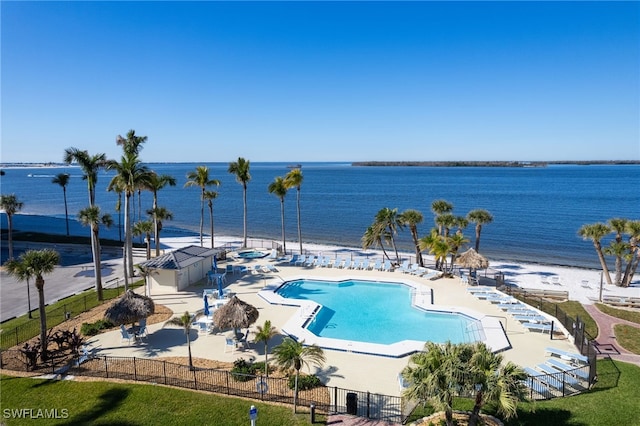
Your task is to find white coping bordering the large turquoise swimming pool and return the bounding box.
[258,274,511,358]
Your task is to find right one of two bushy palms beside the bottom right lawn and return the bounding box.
[463,343,527,426]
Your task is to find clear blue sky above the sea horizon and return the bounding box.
[0,1,640,162]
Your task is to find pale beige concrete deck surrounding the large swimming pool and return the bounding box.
[88,253,576,395]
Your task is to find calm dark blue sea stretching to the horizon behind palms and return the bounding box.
[0,163,640,268]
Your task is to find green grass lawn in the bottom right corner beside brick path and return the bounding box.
[411,360,640,426]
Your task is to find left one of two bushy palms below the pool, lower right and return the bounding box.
[402,342,466,426]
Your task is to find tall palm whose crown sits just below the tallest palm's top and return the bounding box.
[107,151,151,286]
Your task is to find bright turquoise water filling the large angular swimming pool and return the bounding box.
[278,279,477,345]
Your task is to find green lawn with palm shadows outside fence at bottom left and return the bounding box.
[0,376,325,426]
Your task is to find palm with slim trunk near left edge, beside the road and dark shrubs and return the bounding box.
[7,249,60,361]
